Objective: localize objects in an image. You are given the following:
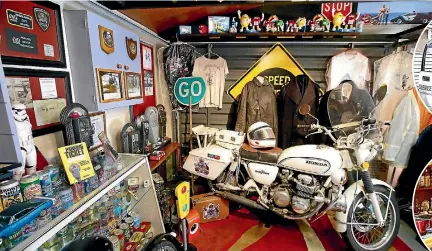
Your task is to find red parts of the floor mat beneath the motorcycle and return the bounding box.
[191,209,411,251]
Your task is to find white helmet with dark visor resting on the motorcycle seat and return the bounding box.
[247,122,276,148]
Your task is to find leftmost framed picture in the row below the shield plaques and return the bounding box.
[96,69,124,103]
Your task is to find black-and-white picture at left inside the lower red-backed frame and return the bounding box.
[6,77,33,108]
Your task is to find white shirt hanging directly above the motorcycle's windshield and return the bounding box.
[326,50,371,91]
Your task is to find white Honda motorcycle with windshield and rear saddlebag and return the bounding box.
[183,84,400,250]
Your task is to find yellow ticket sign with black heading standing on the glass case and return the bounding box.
[58,142,95,185]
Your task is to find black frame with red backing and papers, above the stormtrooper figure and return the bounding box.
[4,68,72,137]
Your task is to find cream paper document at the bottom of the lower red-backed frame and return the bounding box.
[33,98,66,126]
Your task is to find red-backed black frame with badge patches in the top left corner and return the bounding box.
[0,1,66,68]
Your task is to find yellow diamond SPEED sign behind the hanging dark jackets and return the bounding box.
[227,43,312,100]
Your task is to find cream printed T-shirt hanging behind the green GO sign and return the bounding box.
[192,57,228,109]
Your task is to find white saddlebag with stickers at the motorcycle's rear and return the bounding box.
[183,145,234,180]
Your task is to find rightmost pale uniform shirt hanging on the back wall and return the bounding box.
[372,51,414,124]
